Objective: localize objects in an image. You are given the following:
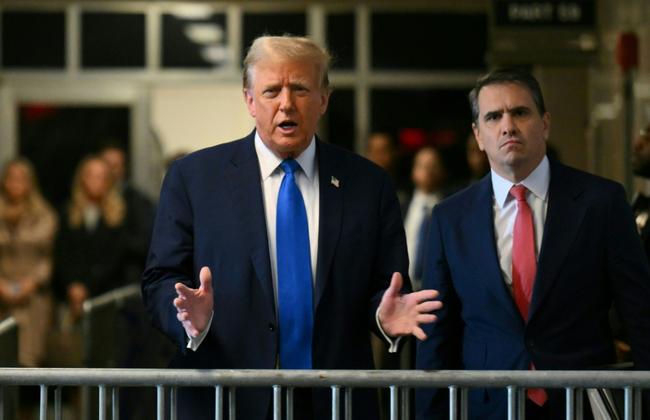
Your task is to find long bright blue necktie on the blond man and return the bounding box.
[276,159,314,369]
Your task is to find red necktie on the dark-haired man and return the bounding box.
[510,185,548,406]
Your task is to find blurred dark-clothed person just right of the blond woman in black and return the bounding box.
[99,142,155,283]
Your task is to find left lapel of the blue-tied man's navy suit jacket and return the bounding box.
[227,132,275,318]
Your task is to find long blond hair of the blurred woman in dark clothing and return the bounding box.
[68,155,126,228]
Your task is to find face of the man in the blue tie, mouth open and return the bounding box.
[244,57,329,158]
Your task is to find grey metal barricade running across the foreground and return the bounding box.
[0,368,650,420]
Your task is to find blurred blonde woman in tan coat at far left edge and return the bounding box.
[0,158,57,367]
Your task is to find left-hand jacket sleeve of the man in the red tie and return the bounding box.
[416,207,462,420]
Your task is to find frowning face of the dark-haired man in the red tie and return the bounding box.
[473,83,551,182]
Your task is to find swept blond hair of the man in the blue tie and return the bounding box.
[243,35,332,89]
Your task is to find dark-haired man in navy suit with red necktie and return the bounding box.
[416,69,650,420]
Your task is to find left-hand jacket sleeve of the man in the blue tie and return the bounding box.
[142,164,197,352]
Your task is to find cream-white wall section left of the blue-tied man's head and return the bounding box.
[151,83,254,156]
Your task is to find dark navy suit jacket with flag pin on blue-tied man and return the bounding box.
[143,134,408,420]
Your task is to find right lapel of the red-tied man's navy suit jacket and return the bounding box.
[529,161,585,319]
